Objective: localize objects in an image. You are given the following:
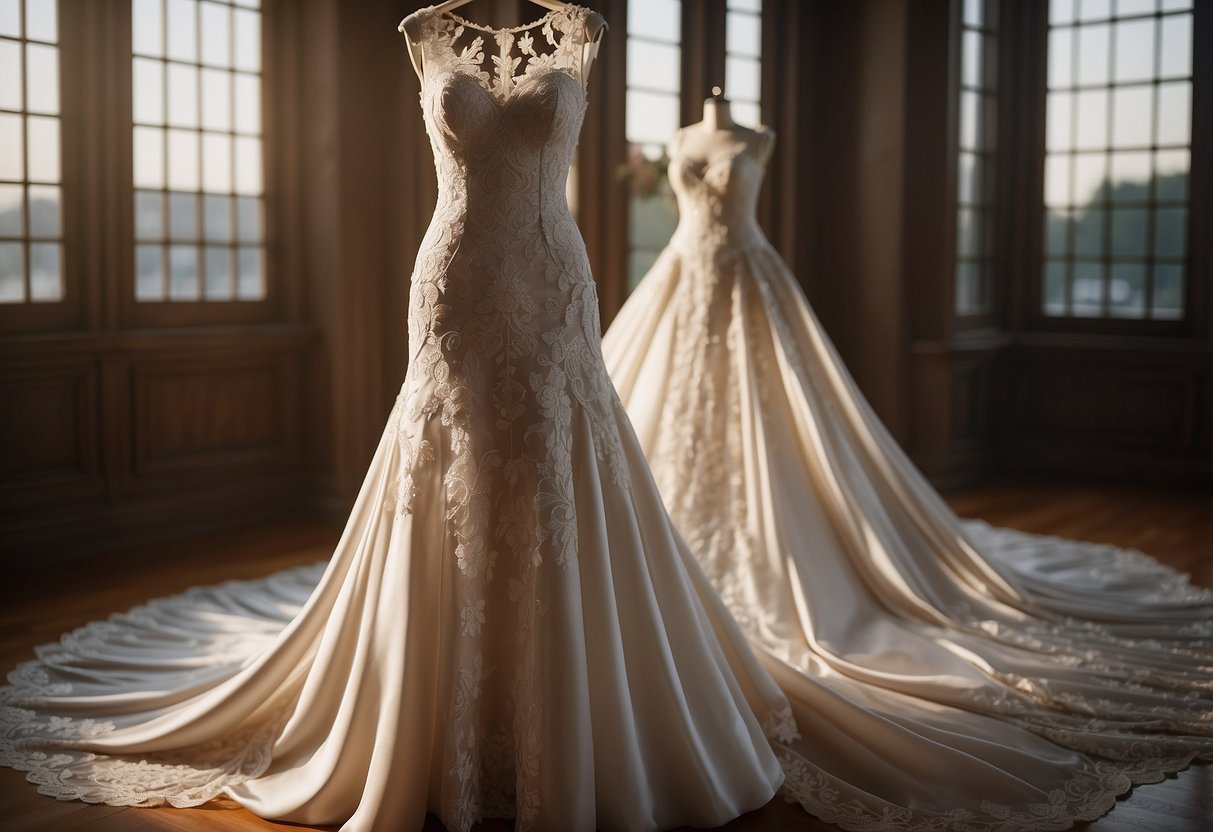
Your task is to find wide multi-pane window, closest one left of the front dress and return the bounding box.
[131,0,266,302]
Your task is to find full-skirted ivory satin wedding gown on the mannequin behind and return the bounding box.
[603,129,1213,830]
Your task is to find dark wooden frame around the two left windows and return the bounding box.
[0,0,278,337]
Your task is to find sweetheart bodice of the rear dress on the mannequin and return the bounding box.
[670,153,765,258]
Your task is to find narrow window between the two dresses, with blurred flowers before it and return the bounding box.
[625,0,682,290]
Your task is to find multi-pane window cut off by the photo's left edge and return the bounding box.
[0,0,64,304]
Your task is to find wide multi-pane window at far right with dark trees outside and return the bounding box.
[1042,0,1192,320]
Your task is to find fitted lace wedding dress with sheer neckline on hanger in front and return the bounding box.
[0,7,795,832]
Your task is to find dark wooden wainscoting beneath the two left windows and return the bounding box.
[0,326,312,570]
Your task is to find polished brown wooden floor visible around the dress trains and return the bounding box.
[0,485,1213,832]
